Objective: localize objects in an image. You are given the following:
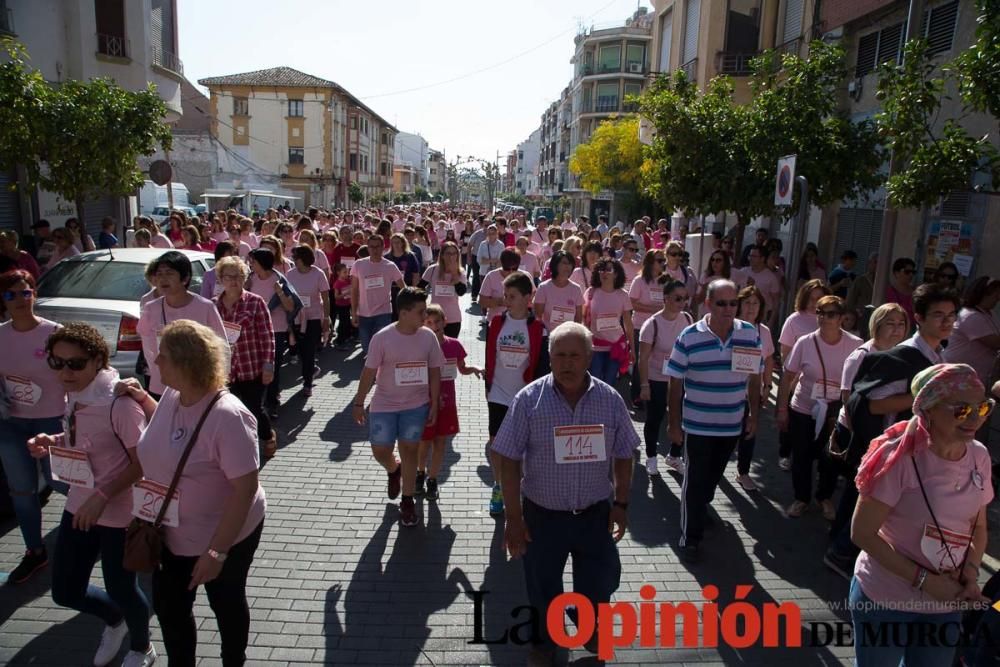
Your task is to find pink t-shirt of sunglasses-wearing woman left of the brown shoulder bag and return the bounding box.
[59,392,146,528]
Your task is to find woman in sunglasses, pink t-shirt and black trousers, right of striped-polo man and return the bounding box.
[778,295,862,521]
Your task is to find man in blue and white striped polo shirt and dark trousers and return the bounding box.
[666,280,763,563]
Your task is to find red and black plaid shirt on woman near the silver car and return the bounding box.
[212,290,274,380]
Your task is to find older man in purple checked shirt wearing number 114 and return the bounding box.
[493,322,639,664]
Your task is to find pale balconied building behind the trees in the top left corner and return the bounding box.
[0,0,184,234]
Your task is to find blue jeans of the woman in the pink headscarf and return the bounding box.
[850,578,962,667]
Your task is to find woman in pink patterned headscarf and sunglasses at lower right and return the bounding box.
[850,364,994,667]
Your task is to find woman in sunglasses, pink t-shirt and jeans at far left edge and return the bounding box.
[0,271,66,584]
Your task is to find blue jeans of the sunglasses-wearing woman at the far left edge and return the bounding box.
[0,417,68,551]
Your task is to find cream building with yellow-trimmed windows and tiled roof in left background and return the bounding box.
[198,67,397,206]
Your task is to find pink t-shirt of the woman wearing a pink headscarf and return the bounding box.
[854,441,993,614]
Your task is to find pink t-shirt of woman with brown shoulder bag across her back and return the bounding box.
[136,389,266,556]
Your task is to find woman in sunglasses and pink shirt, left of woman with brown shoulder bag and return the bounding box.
[28,322,156,667]
